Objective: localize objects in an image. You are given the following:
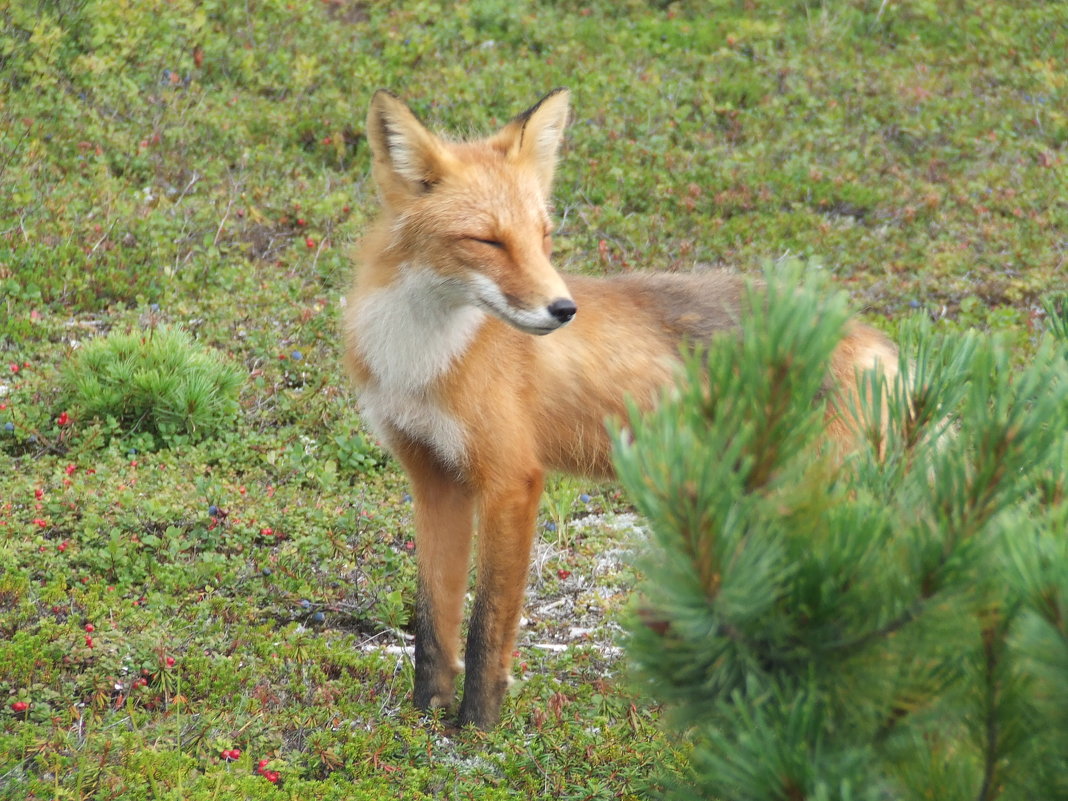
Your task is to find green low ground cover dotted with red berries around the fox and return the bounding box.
[0,0,1068,800]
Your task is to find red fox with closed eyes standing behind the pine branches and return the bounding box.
[343,89,897,728]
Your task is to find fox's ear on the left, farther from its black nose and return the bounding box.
[367,89,450,203]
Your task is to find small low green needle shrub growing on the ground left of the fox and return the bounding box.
[61,326,245,449]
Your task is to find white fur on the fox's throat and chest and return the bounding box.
[348,266,486,465]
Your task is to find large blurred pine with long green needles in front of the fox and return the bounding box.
[616,281,1068,801]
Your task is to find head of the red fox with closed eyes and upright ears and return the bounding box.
[367,89,577,334]
